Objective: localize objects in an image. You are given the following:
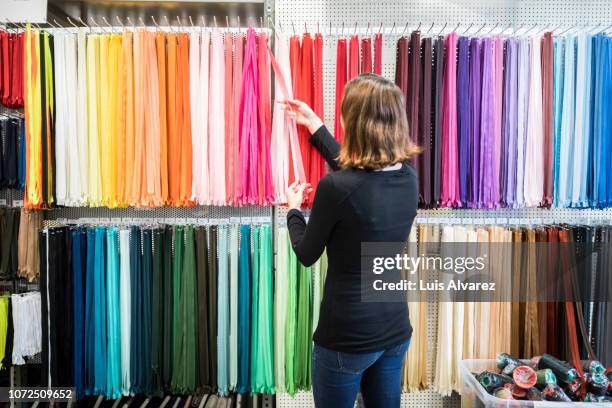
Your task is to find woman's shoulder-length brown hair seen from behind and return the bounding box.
[338,74,421,170]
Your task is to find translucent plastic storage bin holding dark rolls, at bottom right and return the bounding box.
[459,360,612,408]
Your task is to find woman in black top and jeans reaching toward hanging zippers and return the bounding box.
[284,74,419,408]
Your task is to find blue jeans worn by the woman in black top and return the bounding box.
[312,341,410,408]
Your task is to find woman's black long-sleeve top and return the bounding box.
[287,126,418,353]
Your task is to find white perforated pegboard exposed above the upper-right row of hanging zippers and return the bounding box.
[274,0,612,143]
